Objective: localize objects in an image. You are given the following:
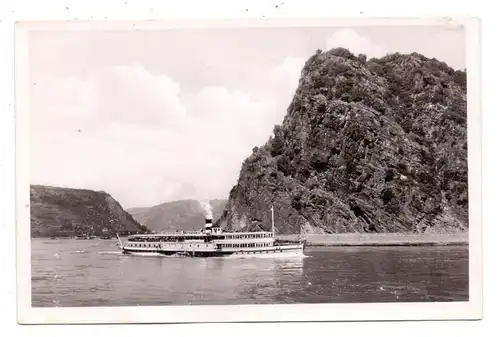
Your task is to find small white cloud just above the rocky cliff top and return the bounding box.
[326,29,386,58]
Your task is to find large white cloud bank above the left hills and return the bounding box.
[31,59,303,207]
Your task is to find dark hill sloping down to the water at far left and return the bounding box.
[30,185,147,237]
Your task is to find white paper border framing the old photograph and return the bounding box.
[15,18,483,324]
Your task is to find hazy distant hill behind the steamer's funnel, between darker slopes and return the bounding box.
[127,200,227,232]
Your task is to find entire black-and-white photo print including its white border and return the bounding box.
[16,19,481,323]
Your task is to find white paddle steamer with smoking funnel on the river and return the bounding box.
[117,208,304,257]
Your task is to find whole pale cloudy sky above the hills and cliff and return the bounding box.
[29,27,465,208]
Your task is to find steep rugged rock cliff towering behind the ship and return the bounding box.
[219,48,468,234]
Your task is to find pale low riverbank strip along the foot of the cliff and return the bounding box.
[277,233,469,246]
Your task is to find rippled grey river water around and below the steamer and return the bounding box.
[31,239,469,307]
